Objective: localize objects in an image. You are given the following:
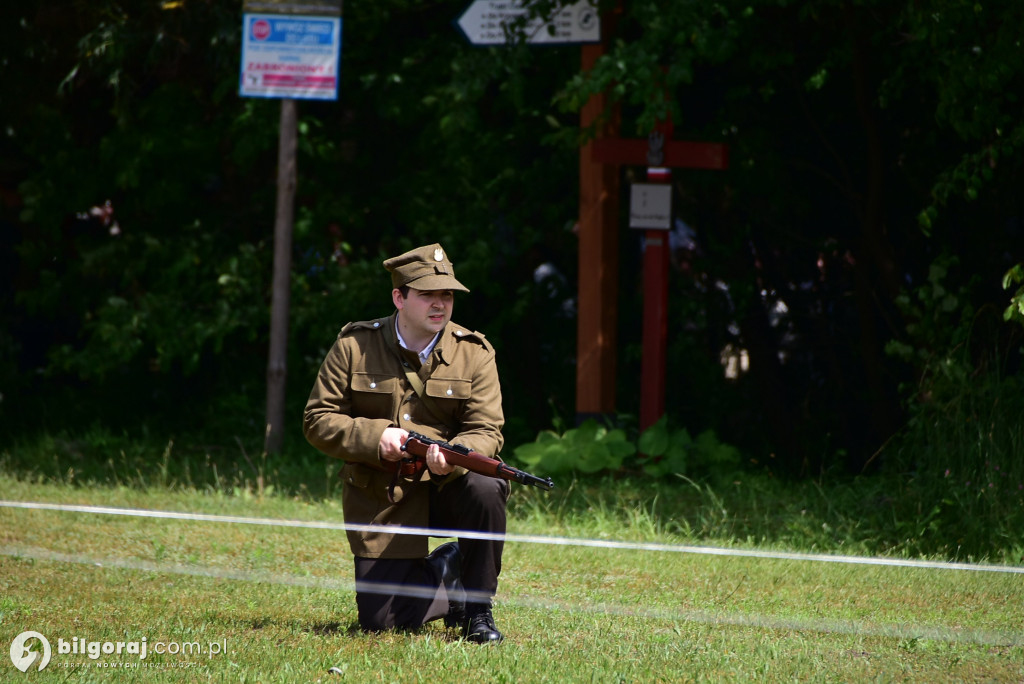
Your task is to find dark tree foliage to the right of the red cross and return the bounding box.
[560,0,1024,467]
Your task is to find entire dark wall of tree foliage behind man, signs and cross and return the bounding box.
[0,0,1024,483]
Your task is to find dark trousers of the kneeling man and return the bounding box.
[355,472,510,630]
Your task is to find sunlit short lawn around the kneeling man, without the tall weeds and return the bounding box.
[0,462,1024,682]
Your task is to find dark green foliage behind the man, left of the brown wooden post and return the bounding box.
[0,0,574,446]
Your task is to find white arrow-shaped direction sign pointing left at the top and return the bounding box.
[457,0,601,45]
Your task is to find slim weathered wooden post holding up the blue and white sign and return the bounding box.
[264,98,298,454]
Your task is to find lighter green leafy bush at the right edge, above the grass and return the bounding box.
[882,257,1024,532]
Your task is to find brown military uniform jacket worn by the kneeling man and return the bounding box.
[302,312,505,558]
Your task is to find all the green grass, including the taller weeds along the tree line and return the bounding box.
[0,429,1024,682]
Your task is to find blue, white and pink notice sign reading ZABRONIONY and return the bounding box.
[239,14,341,99]
